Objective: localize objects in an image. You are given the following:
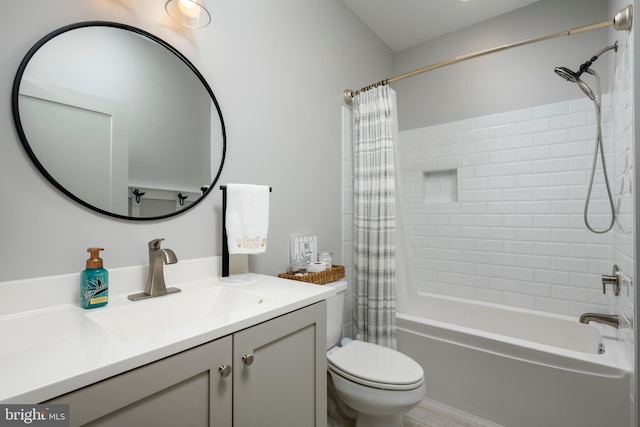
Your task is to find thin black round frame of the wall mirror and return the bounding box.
[11,21,227,221]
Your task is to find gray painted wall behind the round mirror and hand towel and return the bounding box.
[0,0,393,281]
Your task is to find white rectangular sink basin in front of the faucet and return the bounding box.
[87,285,268,341]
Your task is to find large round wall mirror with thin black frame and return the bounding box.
[12,22,226,220]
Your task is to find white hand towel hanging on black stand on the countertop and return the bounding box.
[225,184,269,254]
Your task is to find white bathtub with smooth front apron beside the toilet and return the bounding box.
[397,294,631,427]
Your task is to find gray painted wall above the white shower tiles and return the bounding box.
[392,0,611,130]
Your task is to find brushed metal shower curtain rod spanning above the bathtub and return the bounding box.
[342,5,633,105]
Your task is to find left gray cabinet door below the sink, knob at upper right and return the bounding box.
[49,336,233,427]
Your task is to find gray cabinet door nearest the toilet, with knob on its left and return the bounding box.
[233,301,327,427]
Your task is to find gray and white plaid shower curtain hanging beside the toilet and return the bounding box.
[353,86,396,348]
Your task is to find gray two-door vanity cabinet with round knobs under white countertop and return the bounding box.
[48,302,326,427]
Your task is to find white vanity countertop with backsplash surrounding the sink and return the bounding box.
[0,257,335,404]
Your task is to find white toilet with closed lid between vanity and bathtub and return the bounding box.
[324,281,426,427]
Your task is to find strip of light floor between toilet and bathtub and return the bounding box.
[402,399,501,427]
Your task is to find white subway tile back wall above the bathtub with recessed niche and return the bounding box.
[400,93,632,315]
